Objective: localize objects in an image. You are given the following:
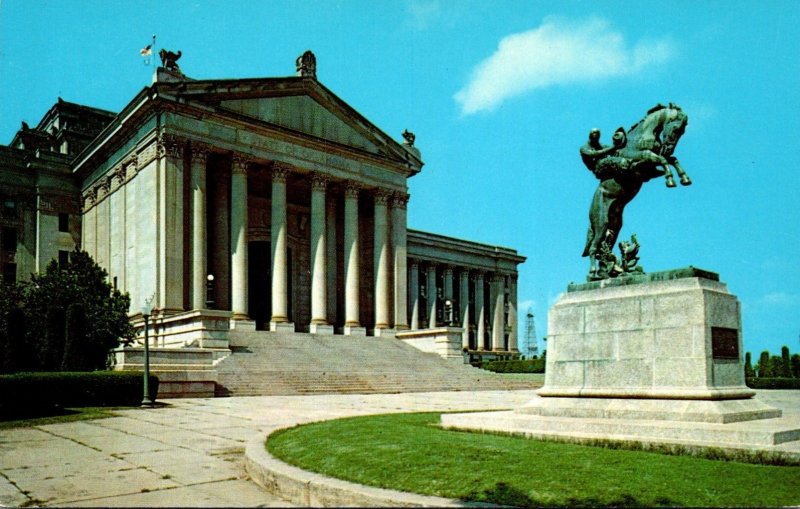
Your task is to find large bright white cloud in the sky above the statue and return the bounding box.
[455,18,673,115]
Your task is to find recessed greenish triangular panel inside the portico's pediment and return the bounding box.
[219,95,381,154]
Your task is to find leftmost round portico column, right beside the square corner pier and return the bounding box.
[191,145,208,309]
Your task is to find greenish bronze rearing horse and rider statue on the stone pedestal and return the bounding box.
[582,103,692,281]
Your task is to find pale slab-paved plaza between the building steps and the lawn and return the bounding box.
[0,390,800,507]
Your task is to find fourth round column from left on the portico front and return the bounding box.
[309,174,333,334]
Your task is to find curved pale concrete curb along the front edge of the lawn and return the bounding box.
[245,430,468,507]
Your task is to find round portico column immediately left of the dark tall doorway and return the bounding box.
[231,154,250,320]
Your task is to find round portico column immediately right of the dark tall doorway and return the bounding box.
[270,163,294,331]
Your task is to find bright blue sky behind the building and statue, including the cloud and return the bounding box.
[0,0,800,356]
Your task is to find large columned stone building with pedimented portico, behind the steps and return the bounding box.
[0,54,524,358]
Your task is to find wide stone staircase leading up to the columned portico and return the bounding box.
[215,331,542,396]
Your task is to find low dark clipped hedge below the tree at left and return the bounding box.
[0,371,158,418]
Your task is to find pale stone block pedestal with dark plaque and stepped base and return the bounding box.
[442,267,800,450]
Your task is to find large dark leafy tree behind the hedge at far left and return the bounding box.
[0,249,133,371]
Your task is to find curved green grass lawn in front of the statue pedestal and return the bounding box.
[267,414,800,507]
